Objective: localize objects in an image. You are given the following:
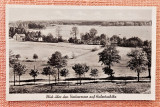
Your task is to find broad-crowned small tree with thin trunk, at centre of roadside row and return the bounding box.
[72,64,89,85]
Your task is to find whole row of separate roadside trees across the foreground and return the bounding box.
[10,42,151,84]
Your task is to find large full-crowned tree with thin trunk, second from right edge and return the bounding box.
[127,49,147,82]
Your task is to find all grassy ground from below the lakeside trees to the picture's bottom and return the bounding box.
[9,39,150,93]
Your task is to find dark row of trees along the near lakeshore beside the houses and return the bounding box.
[9,24,151,47]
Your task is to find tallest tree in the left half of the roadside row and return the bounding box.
[48,51,67,81]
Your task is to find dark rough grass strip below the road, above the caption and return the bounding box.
[9,82,151,94]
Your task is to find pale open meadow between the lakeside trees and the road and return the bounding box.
[9,39,148,82]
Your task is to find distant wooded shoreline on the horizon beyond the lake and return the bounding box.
[9,20,152,29]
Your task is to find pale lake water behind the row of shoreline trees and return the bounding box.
[30,25,152,40]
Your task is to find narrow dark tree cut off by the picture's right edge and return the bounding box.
[143,45,152,78]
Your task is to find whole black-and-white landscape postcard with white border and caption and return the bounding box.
[6,5,156,101]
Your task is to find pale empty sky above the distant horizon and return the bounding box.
[9,7,152,21]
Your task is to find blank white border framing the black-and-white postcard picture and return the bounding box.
[5,4,156,101]
